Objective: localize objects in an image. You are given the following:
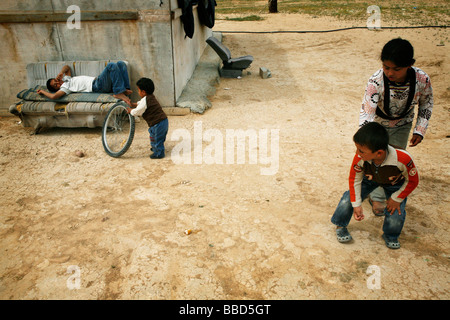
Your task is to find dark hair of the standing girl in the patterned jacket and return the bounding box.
[381,38,416,67]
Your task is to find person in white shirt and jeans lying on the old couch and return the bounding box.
[37,61,132,103]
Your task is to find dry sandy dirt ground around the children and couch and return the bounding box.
[0,14,450,300]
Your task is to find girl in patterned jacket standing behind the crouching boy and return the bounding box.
[359,38,433,215]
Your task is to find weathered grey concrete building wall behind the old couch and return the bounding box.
[0,0,212,113]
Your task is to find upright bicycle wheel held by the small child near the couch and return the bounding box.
[102,102,134,158]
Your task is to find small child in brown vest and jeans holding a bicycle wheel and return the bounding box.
[129,78,169,159]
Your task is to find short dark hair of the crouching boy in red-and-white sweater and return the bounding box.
[353,122,389,152]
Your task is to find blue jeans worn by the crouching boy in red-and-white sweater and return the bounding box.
[331,177,407,241]
